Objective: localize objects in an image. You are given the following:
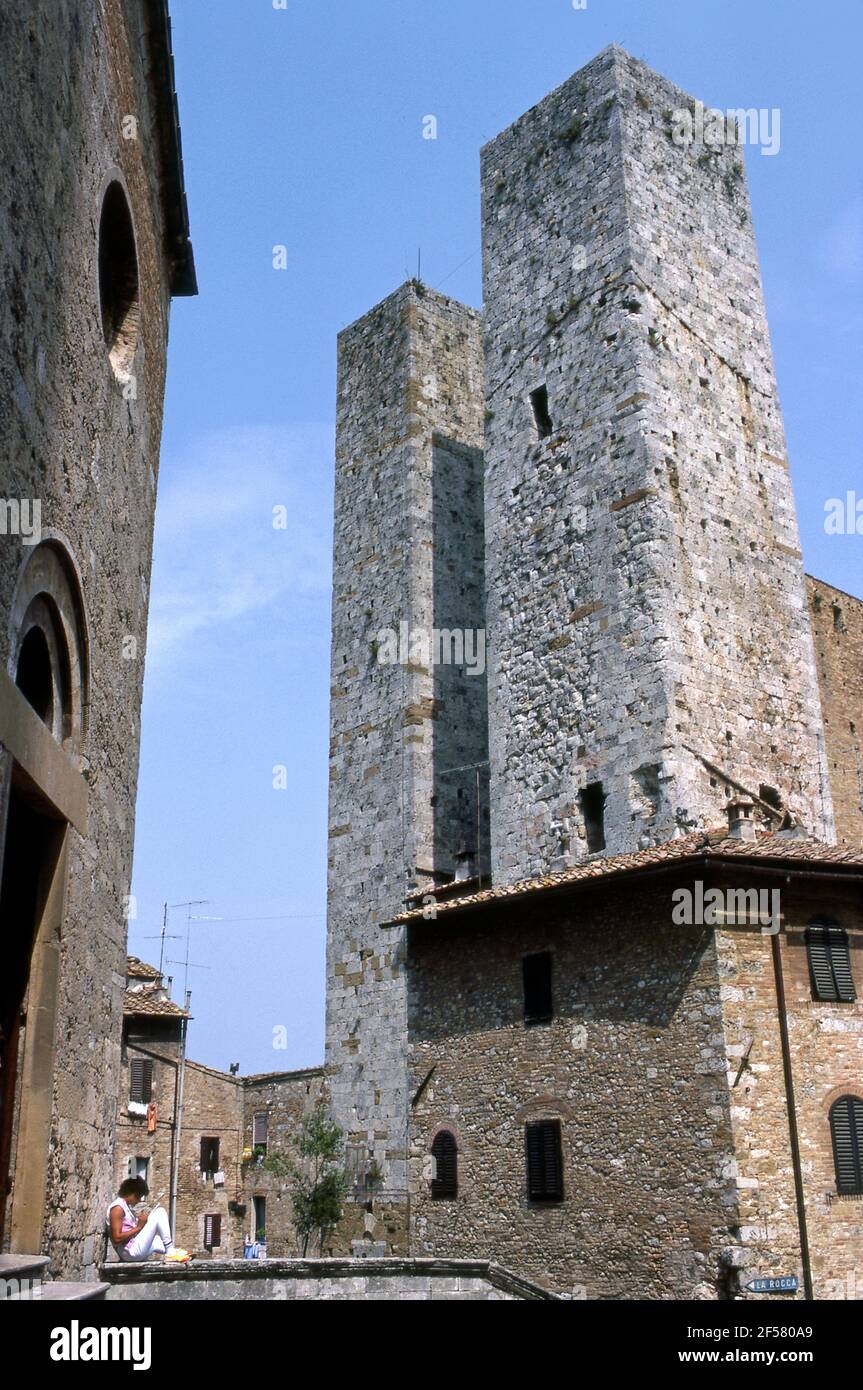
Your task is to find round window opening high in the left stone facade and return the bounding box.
[99,182,140,377]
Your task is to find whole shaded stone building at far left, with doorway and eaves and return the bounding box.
[0,0,196,1273]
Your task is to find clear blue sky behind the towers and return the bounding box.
[124,0,863,1072]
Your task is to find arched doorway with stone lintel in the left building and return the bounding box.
[0,541,88,1252]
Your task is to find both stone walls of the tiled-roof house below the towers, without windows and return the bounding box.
[409,866,863,1298]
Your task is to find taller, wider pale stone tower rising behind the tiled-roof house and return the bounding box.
[482,47,832,883]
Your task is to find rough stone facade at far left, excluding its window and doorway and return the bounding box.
[0,0,188,1275]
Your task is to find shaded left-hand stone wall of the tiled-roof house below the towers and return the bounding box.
[410,884,735,1298]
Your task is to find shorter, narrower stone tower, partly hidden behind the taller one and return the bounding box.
[327,282,488,1204]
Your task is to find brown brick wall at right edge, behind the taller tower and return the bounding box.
[807,577,863,845]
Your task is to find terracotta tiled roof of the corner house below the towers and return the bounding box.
[391,828,863,926]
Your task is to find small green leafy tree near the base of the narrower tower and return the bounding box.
[264,1102,347,1255]
